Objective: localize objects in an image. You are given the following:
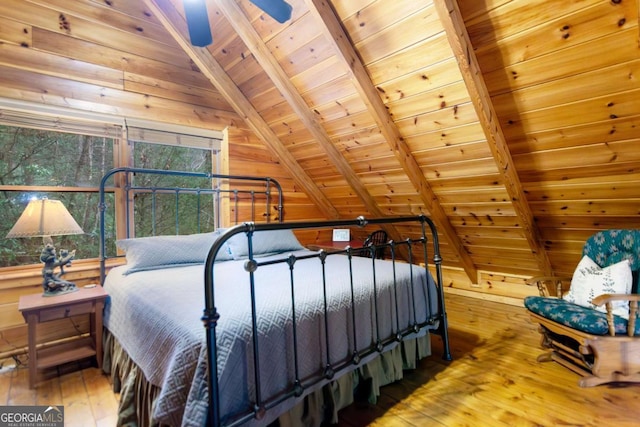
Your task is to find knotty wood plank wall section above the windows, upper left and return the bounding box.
[0,0,240,129]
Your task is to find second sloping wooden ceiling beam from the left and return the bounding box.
[216,0,383,221]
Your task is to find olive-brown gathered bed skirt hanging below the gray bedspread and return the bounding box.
[102,329,431,427]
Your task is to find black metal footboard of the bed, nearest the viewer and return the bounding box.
[202,215,451,427]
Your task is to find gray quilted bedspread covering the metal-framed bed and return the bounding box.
[104,251,438,426]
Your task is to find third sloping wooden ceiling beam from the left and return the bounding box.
[305,0,477,283]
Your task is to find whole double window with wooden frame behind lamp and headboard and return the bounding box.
[0,104,219,267]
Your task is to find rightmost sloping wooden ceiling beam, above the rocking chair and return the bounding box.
[434,0,552,275]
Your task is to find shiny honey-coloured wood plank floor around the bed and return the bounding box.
[0,294,640,427]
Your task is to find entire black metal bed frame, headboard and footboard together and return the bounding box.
[99,168,451,426]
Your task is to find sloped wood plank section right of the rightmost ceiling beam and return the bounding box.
[459,0,640,275]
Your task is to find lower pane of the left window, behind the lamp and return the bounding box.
[0,191,115,267]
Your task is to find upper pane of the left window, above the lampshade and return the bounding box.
[0,126,113,187]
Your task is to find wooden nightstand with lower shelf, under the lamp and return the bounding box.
[18,286,107,388]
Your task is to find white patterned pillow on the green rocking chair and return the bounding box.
[564,255,632,319]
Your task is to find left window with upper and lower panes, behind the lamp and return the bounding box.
[0,125,114,267]
